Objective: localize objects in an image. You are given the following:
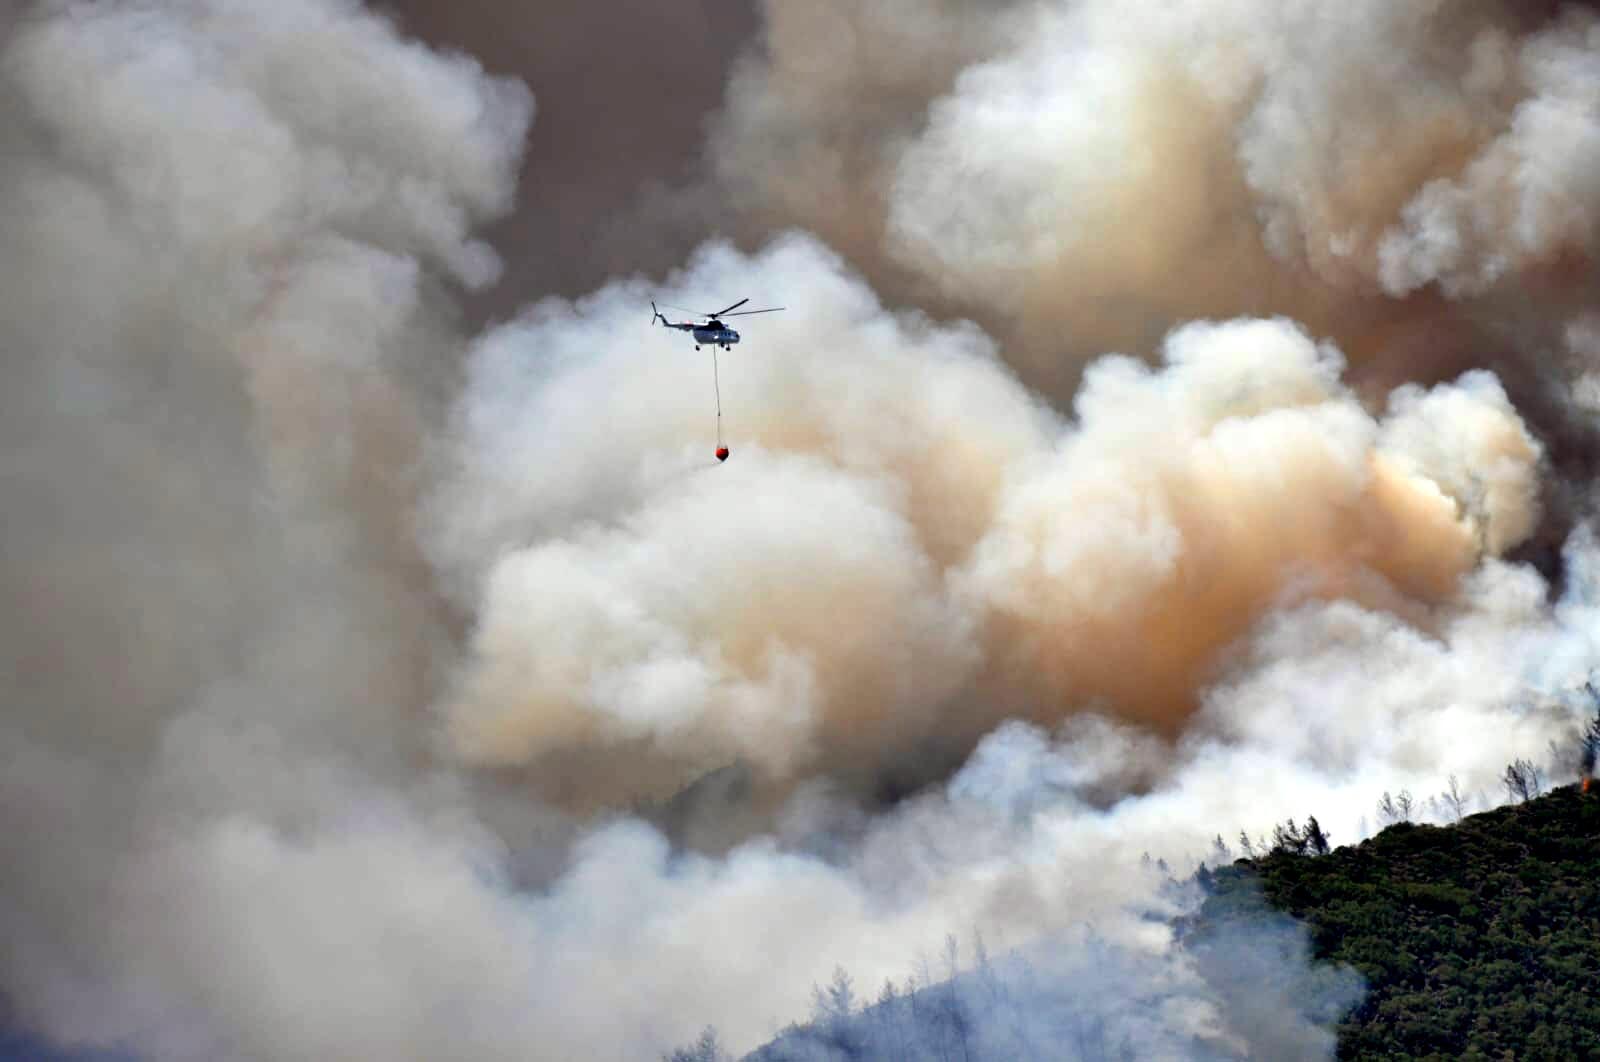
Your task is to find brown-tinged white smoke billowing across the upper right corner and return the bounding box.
[714,0,1600,398]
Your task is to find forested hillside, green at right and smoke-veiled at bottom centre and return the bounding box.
[713,785,1600,1062]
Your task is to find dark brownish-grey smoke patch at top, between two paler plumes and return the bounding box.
[381,0,755,318]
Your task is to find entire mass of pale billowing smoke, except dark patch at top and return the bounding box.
[9,0,1600,1059]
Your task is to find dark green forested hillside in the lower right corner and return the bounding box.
[1181,785,1600,1059]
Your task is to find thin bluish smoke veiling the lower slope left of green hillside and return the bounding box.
[748,914,1362,1062]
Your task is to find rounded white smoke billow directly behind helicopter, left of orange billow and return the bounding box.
[435,238,1050,799]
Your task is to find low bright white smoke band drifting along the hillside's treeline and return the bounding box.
[451,534,1594,1057]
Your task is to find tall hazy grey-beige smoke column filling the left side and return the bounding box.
[0,0,531,1057]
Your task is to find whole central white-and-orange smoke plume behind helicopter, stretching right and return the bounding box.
[438,238,1538,800]
